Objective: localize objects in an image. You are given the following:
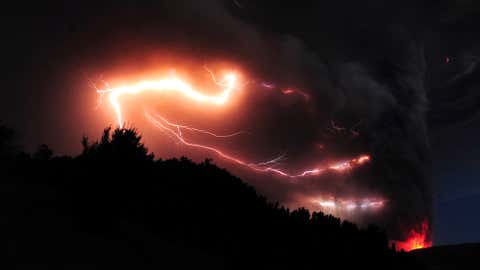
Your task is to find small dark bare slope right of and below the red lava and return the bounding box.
[412,244,480,270]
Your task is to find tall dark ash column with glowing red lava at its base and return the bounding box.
[342,29,433,250]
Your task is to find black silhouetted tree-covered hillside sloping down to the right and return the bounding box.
[0,127,418,269]
